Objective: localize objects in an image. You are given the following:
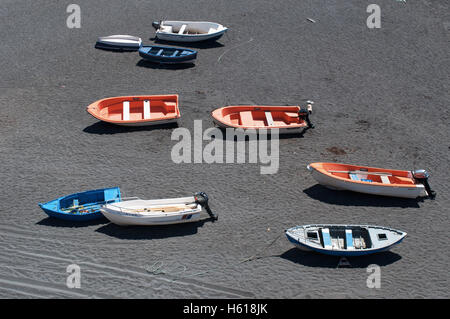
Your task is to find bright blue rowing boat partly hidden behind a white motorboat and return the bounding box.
[39,187,121,221]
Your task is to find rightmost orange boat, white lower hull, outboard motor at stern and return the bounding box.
[307,163,435,198]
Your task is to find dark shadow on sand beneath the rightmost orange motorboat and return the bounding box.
[303,184,424,208]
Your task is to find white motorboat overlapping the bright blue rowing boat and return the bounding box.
[100,193,217,226]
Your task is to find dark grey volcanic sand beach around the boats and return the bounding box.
[0,0,450,298]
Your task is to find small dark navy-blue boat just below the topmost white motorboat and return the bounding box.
[139,45,197,63]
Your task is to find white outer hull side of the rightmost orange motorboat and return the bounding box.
[308,165,427,198]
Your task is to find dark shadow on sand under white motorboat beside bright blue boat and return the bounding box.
[96,218,210,240]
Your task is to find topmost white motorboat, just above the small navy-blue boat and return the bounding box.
[152,21,228,42]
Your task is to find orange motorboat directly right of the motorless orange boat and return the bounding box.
[211,101,314,134]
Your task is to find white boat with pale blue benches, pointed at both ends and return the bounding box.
[286,225,406,256]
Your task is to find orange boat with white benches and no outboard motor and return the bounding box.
[86,94,181,126]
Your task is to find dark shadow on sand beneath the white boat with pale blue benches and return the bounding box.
[279,248,402,268]
